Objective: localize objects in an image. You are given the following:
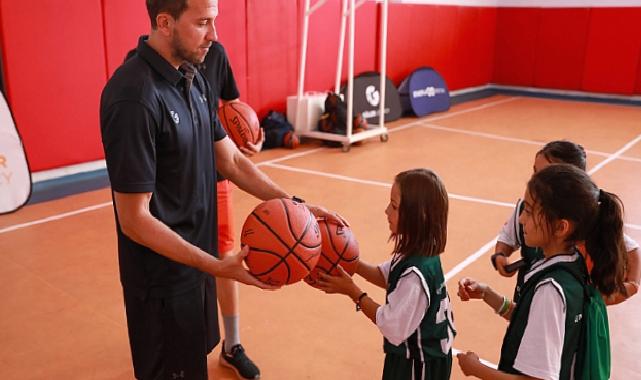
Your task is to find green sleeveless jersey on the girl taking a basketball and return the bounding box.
[384,256,456,361]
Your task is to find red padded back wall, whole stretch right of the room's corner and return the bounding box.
[493,8,641,95]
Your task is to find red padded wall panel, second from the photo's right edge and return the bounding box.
[533,8,590,90]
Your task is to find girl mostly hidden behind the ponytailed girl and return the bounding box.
[492,140,641,304]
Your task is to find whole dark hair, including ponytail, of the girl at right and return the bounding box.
[527,164,626,296]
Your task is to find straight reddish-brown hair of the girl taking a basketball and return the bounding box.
[392,169,448,256]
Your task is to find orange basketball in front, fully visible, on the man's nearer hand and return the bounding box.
[240,199,321,285]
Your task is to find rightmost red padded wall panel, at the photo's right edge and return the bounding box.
[581,8,641,94]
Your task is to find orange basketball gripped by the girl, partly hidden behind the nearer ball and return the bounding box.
[305,219,359,287]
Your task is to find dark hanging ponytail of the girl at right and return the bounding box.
[585,190,626,296]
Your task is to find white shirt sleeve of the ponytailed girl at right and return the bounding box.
[514,278,566,380]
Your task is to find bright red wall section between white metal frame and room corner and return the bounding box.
[387,4,496,89]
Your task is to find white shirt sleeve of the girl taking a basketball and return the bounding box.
[376,267,429,346]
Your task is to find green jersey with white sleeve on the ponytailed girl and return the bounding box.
[498,252,587,380]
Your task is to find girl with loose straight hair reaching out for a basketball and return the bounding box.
[320,169,456,380]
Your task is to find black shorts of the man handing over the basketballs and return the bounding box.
[123,276,220,380]
